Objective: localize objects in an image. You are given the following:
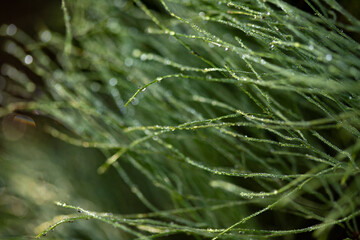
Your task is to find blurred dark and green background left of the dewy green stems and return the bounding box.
[0,0,146,239]
